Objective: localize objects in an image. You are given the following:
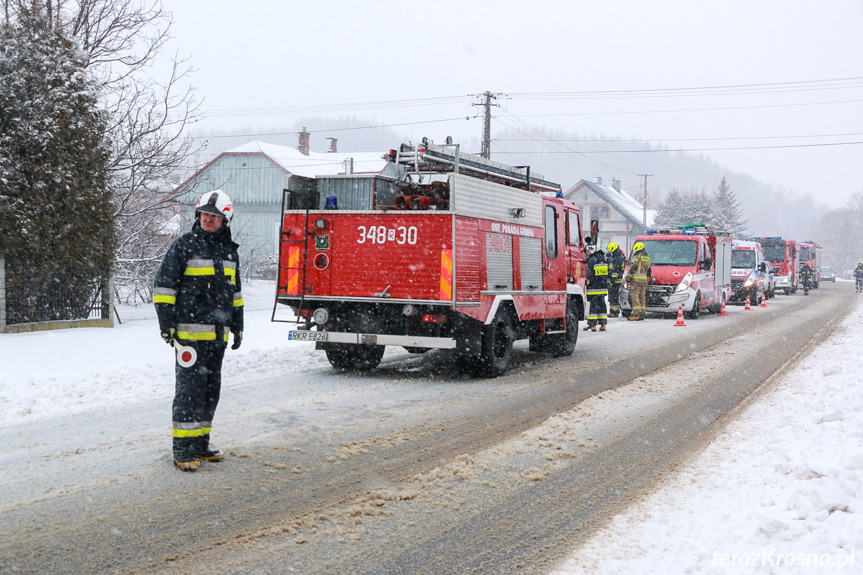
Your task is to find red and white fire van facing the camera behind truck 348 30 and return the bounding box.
[620,225,731,319]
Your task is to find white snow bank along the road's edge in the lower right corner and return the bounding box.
[553,294,863,575]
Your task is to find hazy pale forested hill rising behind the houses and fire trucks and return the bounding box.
[187,118,828,240]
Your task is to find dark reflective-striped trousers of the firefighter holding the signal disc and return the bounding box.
[172,341,227,461]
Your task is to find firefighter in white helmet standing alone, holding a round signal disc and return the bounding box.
[153,190,243,471]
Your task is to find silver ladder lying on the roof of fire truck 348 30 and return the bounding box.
[397,138,561,193]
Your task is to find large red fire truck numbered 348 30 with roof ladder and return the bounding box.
[273,138,586,377]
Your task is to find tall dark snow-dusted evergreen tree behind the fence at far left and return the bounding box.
[0,0,115,323]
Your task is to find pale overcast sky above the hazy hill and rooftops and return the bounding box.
[163,0,863,207]
